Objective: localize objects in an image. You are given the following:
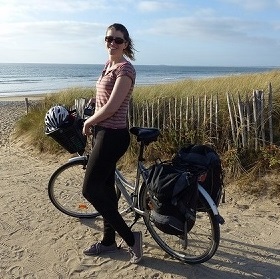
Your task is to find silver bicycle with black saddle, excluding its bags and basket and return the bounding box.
[48,124,224,264]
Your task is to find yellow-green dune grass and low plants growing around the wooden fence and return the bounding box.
[16,71,280,197]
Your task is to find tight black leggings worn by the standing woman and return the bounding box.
[83,126,134,246]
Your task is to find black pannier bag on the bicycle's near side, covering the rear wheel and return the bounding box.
[147,163,198,236]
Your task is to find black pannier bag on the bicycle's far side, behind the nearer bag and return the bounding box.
[172,145,225,210]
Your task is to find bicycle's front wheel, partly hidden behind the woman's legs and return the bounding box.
[48,158,100,218]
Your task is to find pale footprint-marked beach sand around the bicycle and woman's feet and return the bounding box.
[0,99,280,279]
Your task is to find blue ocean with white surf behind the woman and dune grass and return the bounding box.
[0,63,279,97]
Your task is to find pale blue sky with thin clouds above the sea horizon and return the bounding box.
[0,0,280,66]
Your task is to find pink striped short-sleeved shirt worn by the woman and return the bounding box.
[95,61,136,129]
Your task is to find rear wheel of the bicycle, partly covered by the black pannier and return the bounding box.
[139,184,220,264]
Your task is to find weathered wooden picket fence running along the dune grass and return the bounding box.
[75,84,273,153]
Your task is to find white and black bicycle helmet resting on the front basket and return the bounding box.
[45,106,69,130]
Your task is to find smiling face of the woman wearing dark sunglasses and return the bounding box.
[105,28,127,56]
